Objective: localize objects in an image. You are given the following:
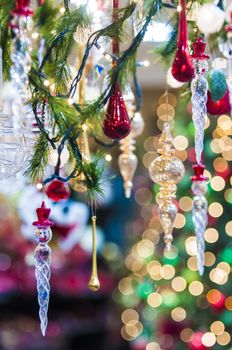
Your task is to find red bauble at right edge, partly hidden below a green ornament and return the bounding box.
[206,89,231,115]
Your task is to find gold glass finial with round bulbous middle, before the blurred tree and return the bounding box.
[149,123,185,250]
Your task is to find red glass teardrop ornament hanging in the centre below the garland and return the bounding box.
[102,84,131,140]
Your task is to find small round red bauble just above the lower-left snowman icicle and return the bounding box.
[46,180,70,202]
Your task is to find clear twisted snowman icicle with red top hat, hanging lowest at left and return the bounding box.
[33,202,54,336]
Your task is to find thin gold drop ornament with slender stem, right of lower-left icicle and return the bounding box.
[88,215,100,292]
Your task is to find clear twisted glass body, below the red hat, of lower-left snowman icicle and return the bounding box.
[34,227,52,336]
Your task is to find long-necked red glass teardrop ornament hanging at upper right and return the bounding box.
[172,0,194,83]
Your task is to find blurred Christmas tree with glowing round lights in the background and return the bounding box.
[118,94,232,350]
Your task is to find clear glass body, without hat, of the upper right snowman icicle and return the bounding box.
[191,60,208,163]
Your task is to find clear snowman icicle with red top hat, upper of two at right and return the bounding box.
[191,37,209,163]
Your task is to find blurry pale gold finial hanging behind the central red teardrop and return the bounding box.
[118,90,144,198]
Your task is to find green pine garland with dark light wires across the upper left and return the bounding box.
[0,0,162,200]
